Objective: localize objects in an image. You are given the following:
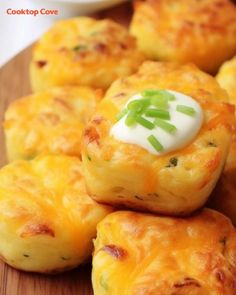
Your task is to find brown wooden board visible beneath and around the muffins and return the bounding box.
[0,3,132,295]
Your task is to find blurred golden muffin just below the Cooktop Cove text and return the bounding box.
[31,17,143,91]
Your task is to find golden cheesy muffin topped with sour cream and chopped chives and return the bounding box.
[81,62,235,216]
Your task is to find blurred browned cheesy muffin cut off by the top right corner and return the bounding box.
[130,0,236,73]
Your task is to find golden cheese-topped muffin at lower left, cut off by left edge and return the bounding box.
[0,155,111,273]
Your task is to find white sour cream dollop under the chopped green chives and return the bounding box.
[110,90,204,155]
